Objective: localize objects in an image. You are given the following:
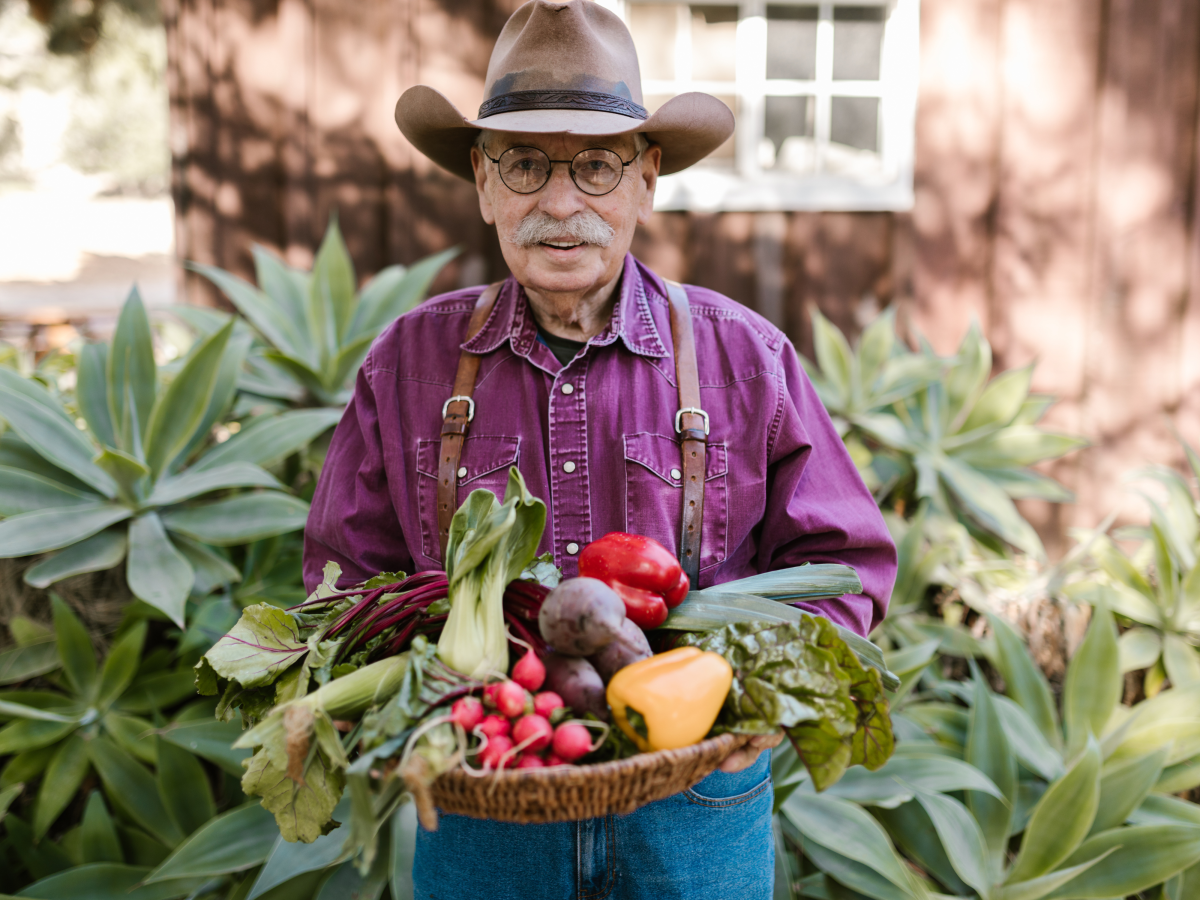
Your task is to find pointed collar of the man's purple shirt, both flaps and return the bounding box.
[461,253,667,359]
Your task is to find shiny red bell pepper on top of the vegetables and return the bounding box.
[580,532,690,630]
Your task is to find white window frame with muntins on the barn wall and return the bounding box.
[596,0,920,212]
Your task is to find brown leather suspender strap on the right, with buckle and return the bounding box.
[664,278,708,590]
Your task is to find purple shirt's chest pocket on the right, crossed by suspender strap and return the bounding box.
[625,432,728,581]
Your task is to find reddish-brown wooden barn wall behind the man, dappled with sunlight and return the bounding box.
[166,0,1200,550]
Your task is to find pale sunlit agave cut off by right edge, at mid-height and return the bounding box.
[1068,444,1200,697]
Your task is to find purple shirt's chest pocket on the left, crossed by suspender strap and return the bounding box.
[416,434,521,562]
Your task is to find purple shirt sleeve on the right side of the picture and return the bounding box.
[757,342,896,636]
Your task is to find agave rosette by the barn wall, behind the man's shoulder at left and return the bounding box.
[188,218,458,407]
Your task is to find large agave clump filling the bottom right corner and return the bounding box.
[776,606,1200,900]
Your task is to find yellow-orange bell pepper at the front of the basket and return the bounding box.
[607,647,733,752]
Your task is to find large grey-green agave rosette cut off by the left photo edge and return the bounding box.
[0,289,319,625]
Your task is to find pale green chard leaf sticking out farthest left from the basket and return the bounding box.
[196,604,308,692]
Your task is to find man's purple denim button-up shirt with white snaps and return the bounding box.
[304,256,896,635]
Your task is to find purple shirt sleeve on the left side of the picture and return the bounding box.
[304,356,413,592]
